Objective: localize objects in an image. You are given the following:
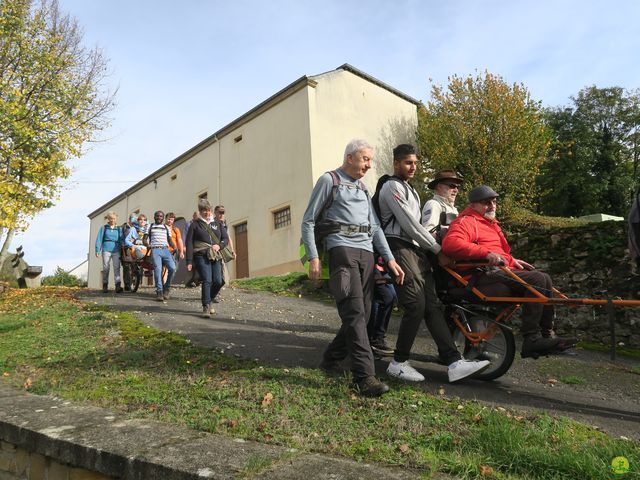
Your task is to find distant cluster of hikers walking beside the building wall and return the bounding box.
[95,199,235,317]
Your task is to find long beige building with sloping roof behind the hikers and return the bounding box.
[88,64,419,288]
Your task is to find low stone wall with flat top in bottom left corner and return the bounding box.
[0,386,421,480]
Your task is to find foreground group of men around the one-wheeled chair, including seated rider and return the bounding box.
[302,139,576,396]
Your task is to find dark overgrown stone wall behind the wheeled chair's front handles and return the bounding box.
[505,222,640,348]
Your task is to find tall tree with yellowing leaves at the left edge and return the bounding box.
[0,0,114,266]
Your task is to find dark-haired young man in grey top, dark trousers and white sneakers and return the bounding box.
[379,144,489,382]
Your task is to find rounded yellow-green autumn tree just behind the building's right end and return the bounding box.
[418,72,550,213]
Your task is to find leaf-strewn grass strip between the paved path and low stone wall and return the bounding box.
[0,287,640,479]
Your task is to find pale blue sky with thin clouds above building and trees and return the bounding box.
[12,0,640,274]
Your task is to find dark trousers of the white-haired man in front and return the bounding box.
[324,247,376,381]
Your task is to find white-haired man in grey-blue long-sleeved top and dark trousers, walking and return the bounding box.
[302,139,404,396]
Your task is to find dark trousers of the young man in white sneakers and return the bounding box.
[387,238,462,365]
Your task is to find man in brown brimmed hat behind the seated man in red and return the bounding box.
[421,170,462,236]
